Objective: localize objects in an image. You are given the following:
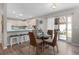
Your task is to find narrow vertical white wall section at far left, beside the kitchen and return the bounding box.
[2,3,7,49]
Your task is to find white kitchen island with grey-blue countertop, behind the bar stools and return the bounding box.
[7,29,32,45]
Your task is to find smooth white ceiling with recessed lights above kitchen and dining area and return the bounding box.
[7,3,79,19]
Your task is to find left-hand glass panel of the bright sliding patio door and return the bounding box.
[59,16,67,40]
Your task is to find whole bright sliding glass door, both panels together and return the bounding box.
[59,16,72,41]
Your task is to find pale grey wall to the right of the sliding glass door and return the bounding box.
[72,9,79,44]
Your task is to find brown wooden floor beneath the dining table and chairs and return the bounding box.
[0,41,79,55]
